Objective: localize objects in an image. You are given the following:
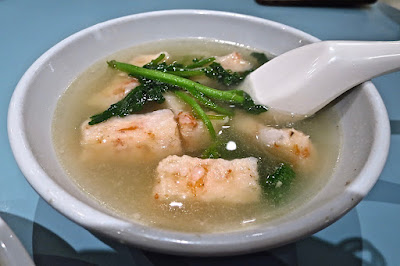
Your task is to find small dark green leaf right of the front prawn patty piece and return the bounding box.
[260,163,296,203]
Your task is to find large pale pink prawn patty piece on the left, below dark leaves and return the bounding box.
[81,109,183,162]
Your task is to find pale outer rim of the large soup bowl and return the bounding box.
[7,9,390,256]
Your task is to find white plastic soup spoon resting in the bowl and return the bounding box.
[242,41,400,116]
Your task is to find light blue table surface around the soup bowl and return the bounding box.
[0,0,400,265]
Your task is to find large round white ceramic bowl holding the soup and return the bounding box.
[8,10,390,255]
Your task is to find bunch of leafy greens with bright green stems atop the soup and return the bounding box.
[89,54,267,152]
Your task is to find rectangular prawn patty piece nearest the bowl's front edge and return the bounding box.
[153,155,261,203]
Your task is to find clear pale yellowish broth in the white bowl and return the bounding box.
[53,39,340,232]
